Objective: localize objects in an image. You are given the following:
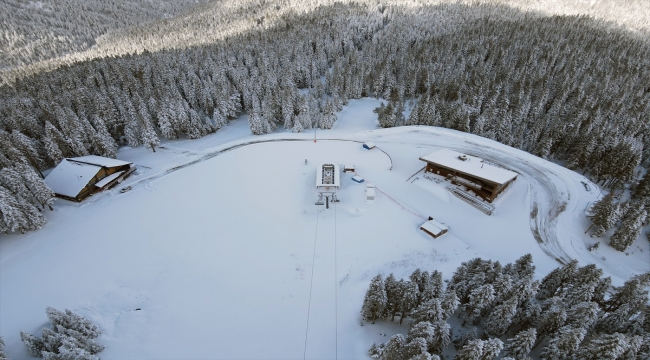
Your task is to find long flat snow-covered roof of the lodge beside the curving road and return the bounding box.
[420,149,517,184]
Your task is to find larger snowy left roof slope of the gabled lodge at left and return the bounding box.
[44,159,101,198]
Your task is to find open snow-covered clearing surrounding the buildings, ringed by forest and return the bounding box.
[0,99,650,359]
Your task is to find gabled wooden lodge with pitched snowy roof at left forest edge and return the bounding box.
[45,155,136,201]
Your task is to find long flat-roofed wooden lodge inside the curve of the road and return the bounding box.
[420,149,517,202]
